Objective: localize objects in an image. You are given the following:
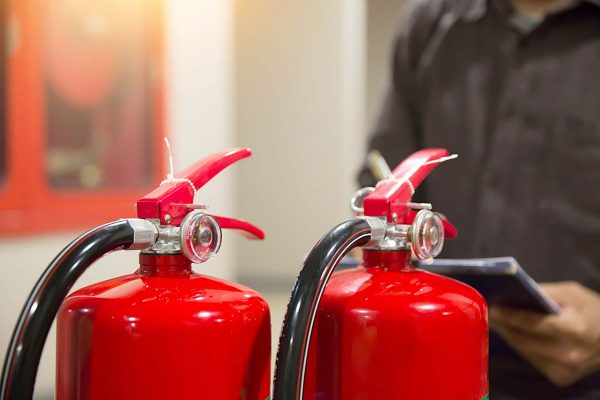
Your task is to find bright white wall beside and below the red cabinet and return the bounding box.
[0,0,235,398]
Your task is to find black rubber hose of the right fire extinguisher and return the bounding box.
[273,218,371,400]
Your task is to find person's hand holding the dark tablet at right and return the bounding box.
[490,282,600,387]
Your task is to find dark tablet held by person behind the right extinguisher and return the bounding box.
[415,257,560,314]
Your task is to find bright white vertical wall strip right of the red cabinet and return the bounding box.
[165,0,238,278]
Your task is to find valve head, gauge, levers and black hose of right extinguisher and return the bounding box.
[273,149,456,400]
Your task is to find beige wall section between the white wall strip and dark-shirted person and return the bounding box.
[235,0,365,286]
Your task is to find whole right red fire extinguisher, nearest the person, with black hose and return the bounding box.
[273,149,488,400]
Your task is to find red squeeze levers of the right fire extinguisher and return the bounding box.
[363,149,457,238]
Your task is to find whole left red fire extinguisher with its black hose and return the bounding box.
[1,149,271,400]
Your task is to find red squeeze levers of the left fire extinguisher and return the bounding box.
[137,148,265,239]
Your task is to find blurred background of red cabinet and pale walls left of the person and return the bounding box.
[0,0,402,399]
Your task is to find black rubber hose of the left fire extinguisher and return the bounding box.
[0,220,134,400]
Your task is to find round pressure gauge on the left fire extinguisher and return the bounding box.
[179,211,221,264]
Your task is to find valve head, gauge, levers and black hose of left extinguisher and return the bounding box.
[0,149,264,400]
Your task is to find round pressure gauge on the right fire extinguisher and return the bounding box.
[411,210,444,260]
